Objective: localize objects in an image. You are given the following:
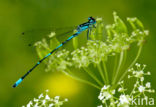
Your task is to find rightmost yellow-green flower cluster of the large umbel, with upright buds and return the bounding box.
[106,12,148,52]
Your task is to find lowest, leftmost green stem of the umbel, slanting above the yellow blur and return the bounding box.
[62,71,101,90]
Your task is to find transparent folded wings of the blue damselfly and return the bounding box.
[20,27,76,46]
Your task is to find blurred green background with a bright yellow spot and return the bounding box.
[0,0,156,107]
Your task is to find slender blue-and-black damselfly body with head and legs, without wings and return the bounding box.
[13,17,96,88]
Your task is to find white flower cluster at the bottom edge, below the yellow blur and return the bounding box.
[22,90,68,107]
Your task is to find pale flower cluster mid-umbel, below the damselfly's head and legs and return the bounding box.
[71,41,111,68]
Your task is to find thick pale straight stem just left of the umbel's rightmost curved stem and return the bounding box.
[112,51,124,85]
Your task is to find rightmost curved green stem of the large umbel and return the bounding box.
[115,45,142,87]
